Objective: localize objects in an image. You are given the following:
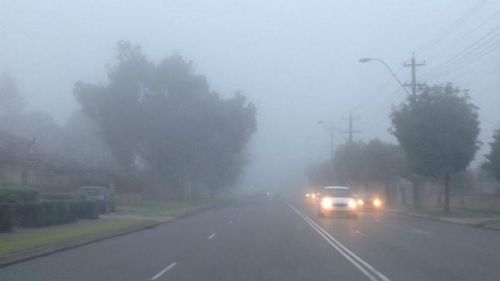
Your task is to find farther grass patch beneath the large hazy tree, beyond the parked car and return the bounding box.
[118,199,232,217]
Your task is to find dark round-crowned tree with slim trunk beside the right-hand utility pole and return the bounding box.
[391,84,479,211]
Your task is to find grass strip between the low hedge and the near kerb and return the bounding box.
[0,219,153,256]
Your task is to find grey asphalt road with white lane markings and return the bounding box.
[0,199,500,281]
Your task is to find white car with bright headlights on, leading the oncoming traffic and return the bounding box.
[318,186,359,218]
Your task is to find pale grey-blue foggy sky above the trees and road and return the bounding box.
[0,0,500,187]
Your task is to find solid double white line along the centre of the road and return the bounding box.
[287,202,390,281]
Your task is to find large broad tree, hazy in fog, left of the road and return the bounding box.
[74,42,256,199]
